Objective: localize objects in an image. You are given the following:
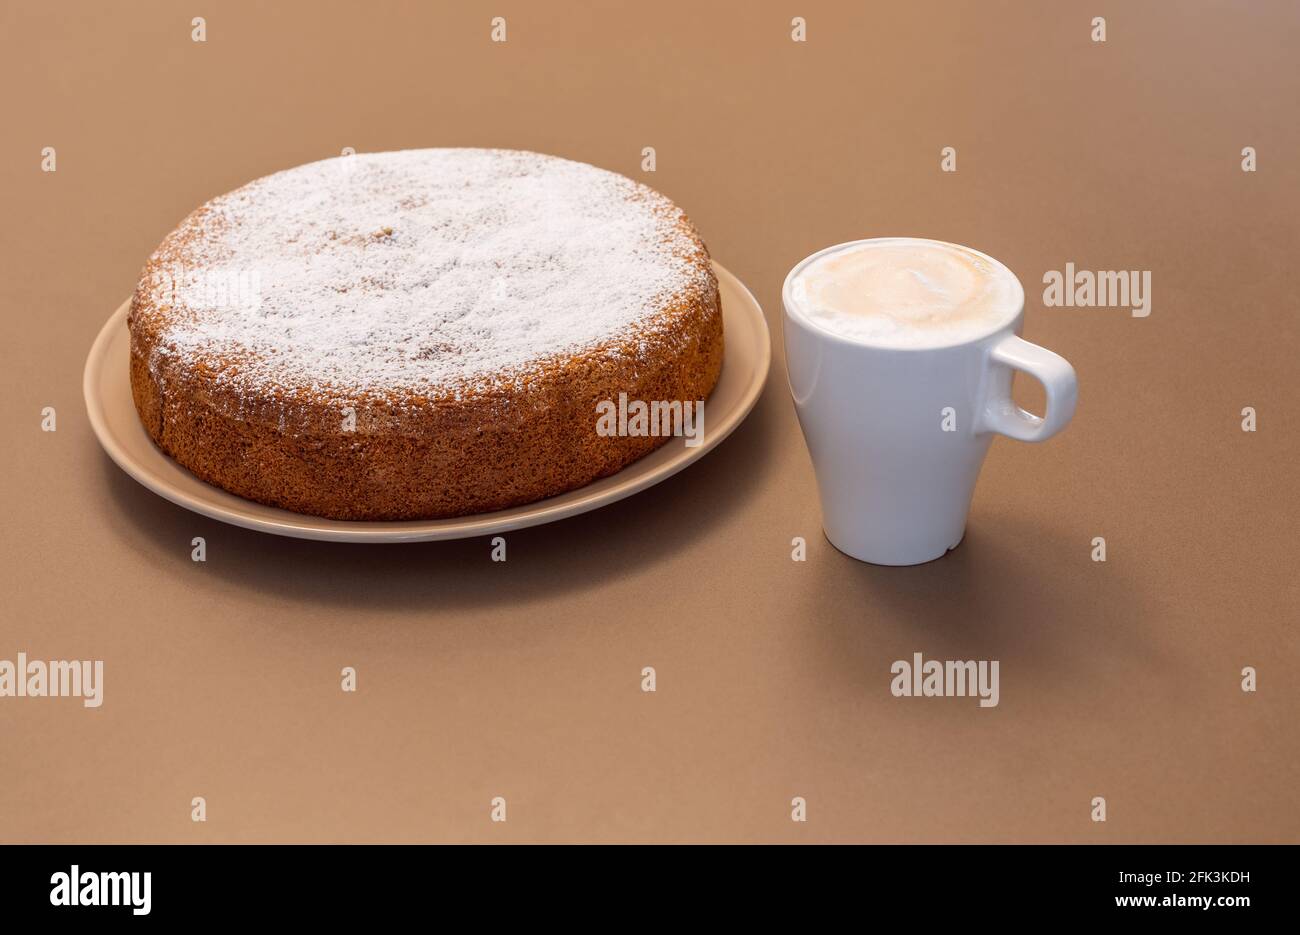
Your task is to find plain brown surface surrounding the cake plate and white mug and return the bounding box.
[0,0,1300,841]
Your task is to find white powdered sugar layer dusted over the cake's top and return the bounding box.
[151,150,709,399]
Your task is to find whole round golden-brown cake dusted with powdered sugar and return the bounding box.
[129,150,723,520]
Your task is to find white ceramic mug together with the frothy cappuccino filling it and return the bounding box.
[781,238,1079,566]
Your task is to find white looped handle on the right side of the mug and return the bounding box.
[976,334,1079,442]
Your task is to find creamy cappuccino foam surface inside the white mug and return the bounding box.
[789,237,1024,349]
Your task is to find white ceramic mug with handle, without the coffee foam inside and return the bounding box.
[781,238,1078,564]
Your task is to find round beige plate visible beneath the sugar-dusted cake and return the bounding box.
[83,263,772,542]
